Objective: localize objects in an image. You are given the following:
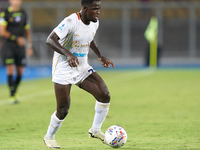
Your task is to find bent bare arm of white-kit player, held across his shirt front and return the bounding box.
[46,31,79,67]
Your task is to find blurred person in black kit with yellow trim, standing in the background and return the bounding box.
[0,0,33,104]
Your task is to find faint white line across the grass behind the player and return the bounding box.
[0,71,155,105]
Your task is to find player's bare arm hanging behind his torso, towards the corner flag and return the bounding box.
[90,40,115,68]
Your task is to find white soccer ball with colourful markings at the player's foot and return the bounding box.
[105,125,127,148]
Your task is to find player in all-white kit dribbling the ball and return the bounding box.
[44,0,114,148]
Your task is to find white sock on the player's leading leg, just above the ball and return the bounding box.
[92,101,110,132]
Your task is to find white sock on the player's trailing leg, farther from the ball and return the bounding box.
[46,111,64,139]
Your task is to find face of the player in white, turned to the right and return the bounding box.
[87,1,101,22]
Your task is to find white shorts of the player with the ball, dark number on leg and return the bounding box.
[52,66,95,85]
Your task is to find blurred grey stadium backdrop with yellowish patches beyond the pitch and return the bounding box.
[0,0,200,65]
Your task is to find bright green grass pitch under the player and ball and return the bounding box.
[0,70,200,150]
